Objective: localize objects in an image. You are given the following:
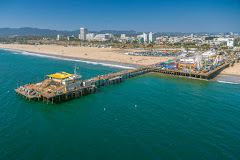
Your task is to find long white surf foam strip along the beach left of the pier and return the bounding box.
[4,49,134,69]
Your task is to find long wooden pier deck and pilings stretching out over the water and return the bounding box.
[15,59,234,104]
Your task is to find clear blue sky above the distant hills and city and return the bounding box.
[0,0,240,32]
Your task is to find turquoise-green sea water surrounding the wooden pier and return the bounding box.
[0,50,240,160]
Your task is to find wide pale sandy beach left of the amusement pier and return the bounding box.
[0,44,173,66]
